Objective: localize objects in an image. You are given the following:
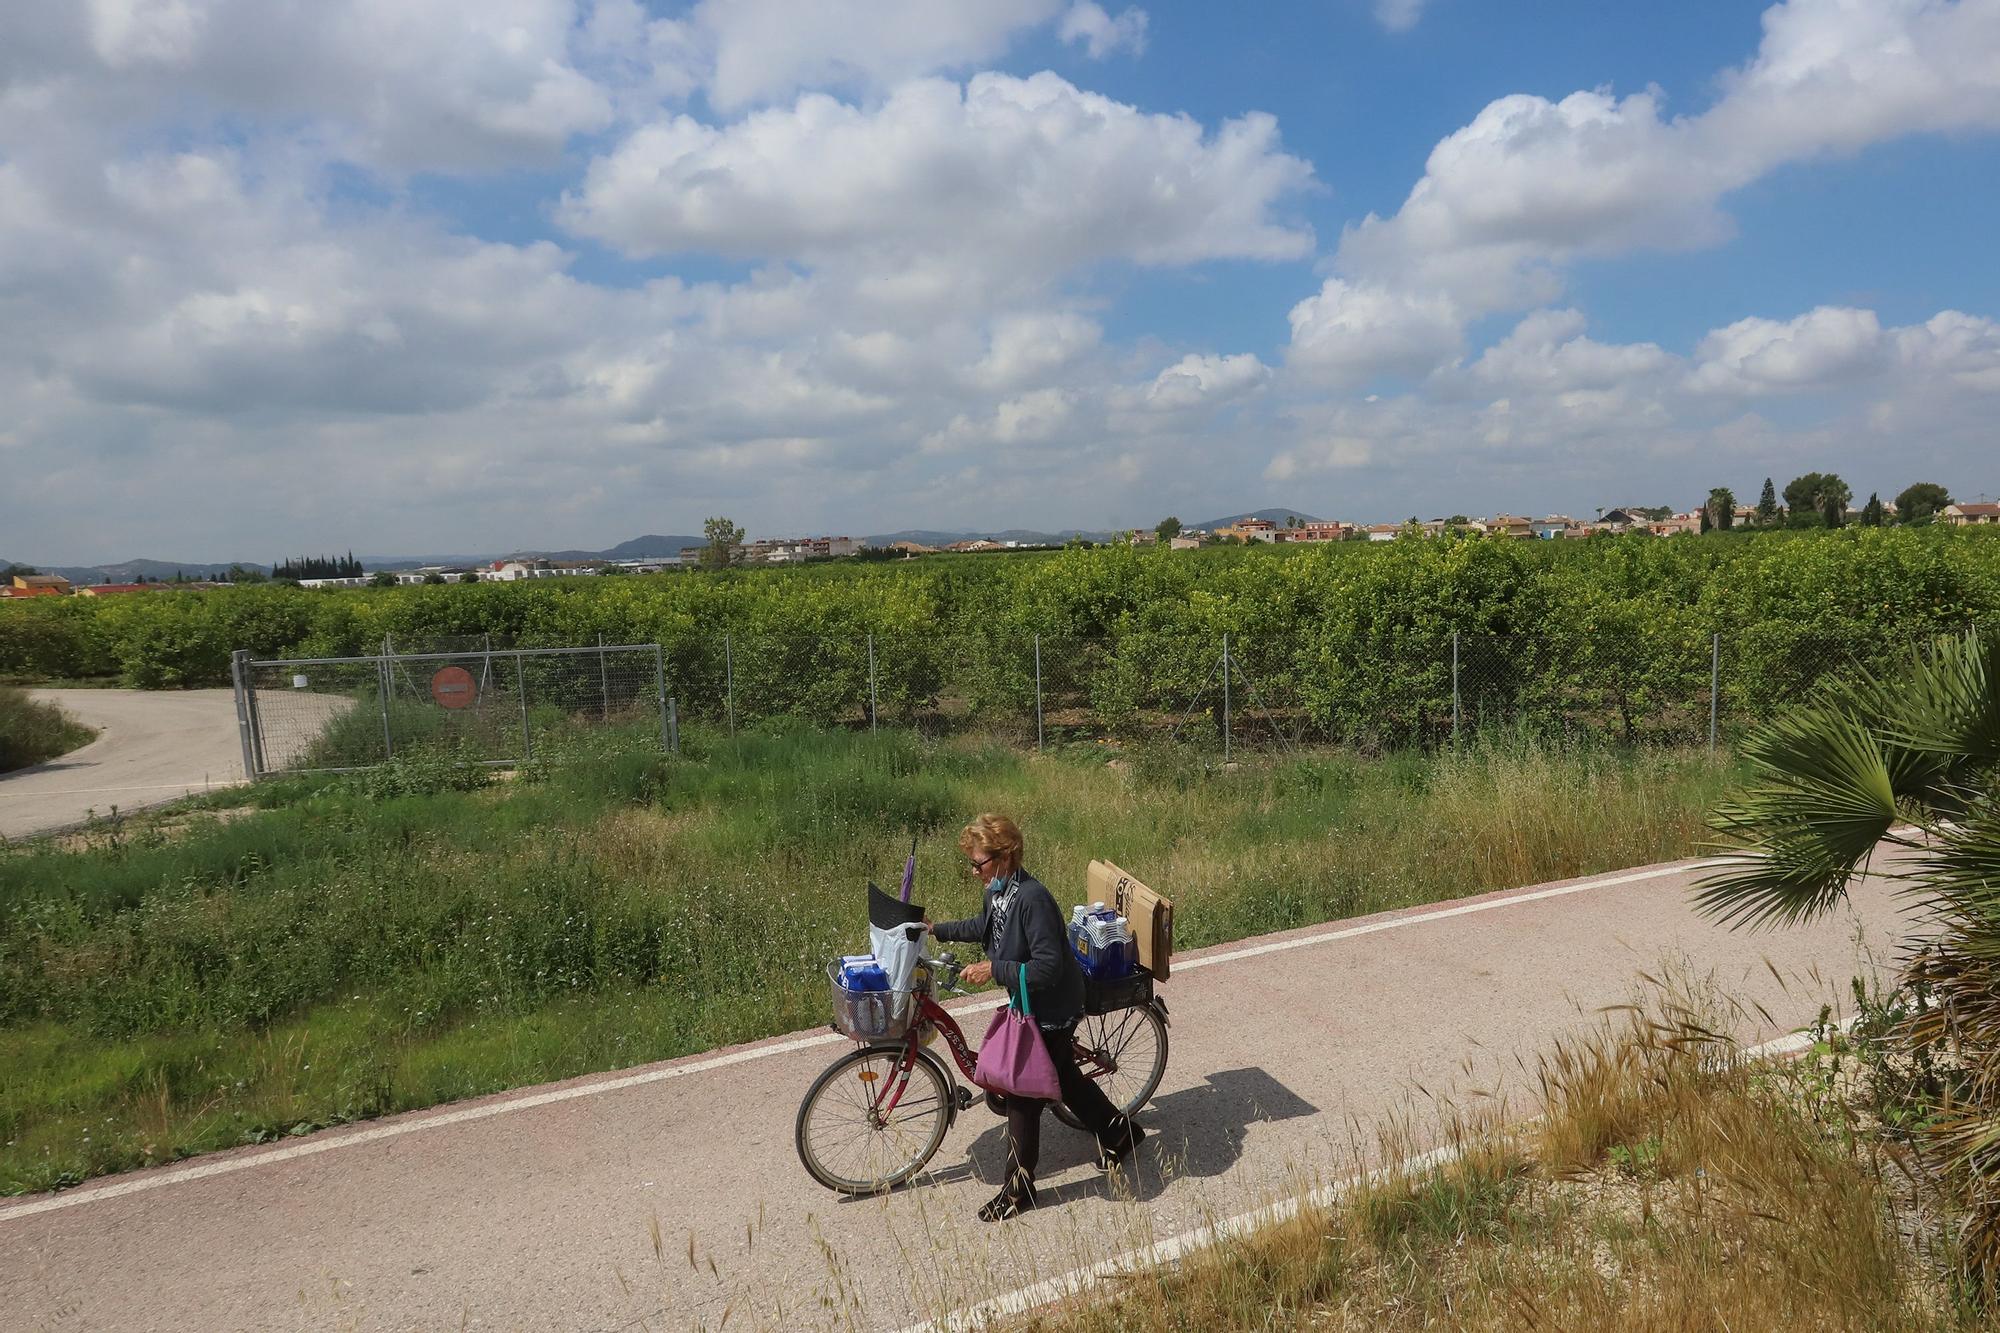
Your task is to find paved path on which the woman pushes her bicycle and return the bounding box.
[0,865,1898,1329]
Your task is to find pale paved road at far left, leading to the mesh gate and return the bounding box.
[0,691,244,839]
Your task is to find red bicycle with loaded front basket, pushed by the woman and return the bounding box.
[792,953,1168,1195]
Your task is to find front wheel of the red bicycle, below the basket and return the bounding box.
[792,1045,952,1195]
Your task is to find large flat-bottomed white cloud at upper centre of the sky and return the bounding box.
[562,72,1312,274]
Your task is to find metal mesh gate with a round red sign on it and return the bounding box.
[232,636,678,777]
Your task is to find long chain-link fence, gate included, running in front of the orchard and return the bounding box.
[238,620,1984,773]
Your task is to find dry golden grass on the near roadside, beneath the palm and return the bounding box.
[1010,992,1992,1333]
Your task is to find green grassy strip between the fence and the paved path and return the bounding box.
[0,731,1728,1193]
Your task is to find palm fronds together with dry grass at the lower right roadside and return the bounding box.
[1022,634,2000,1333]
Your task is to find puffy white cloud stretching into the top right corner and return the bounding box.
[1304,0,2000,378]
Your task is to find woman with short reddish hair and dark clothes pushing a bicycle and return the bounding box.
[926,815,1146,1221]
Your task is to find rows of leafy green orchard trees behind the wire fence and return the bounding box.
[0,526,2000,739]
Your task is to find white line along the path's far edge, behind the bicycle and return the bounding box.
[0,861,1720,1223]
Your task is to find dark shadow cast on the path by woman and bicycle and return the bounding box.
[960,1069,1318,1207]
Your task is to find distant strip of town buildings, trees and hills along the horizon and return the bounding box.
[0,490,2000,598]
